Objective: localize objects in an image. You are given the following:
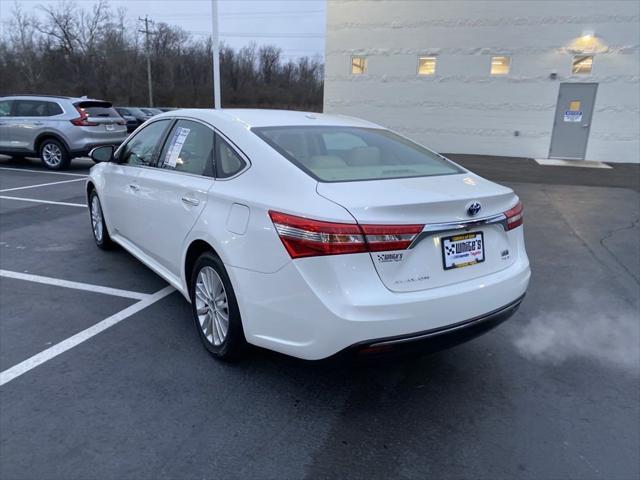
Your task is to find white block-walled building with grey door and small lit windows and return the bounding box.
[324,0,640,162]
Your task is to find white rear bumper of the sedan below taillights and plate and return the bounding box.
[227,250,531,360]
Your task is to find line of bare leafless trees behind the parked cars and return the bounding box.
[0,0,323,111]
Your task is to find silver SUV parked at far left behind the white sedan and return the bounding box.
[0,95,127,170]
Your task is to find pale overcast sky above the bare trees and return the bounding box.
[0,0,325,58]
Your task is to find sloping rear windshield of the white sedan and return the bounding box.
[252,126,463,182]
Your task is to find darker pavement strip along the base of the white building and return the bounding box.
[443,153,640,191]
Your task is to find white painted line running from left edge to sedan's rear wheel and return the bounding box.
[0,286,175,387]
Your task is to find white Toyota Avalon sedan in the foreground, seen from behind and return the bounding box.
[86,110,530,359]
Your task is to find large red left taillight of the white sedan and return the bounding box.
[269,211,424,258]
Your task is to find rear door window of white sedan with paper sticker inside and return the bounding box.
[158,120,215,177]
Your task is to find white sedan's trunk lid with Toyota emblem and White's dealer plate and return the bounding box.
[317,173,518,292]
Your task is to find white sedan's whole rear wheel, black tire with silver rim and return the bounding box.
[189,252,247,360]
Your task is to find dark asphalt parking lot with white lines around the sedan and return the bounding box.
[0,159,640,480]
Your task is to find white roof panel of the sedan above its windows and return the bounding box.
[156,108,382,128]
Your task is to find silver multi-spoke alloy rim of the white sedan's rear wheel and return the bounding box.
[195,266,229,347]
